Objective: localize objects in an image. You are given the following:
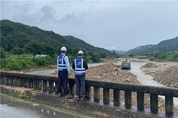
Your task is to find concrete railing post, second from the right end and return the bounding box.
[150,94,158,113]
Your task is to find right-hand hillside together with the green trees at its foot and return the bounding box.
[126,37,178,62]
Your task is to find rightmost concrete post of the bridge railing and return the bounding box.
[165,96,173,115]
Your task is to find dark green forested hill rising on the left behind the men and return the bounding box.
[1,20,111,55]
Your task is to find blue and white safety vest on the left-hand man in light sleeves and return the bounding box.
[58,54,67,71]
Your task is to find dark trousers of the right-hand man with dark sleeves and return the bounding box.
[75,77,85,97]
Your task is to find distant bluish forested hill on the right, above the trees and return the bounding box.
[126,37,178,54]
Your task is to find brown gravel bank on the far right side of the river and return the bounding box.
[141,62,178,88]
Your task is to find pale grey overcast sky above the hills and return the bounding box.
[0,0,178,51]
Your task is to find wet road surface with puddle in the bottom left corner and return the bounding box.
[0,94,95,118]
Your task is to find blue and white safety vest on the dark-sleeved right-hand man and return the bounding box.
[74,58,85,76]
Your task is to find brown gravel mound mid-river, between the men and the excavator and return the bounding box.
[70,63,140,84]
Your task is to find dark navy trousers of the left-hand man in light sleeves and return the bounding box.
[58,71,69,95]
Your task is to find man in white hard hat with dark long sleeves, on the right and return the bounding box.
[72,50,88,101]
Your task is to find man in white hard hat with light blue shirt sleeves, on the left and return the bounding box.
[57,47,71,98]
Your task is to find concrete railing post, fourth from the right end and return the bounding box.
[125,91,132,108]
